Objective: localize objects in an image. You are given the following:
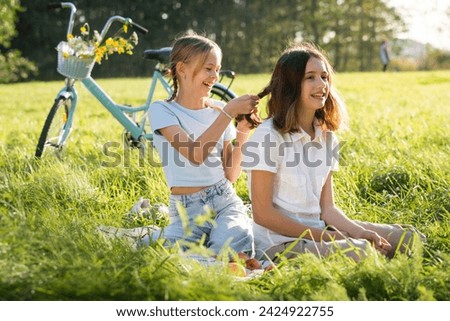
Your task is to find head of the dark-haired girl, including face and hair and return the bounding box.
[268,43,345,133]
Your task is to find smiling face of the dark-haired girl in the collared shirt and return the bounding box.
[300,56,330,112]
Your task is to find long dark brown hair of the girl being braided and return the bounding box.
[258,43,345,133]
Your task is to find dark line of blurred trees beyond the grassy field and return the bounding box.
[0,0,436,79]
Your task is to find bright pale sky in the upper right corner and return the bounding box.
[386,0,450,50]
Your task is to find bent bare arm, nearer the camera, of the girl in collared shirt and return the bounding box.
[251,170,342,241]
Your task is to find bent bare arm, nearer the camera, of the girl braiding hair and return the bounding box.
[159,95,259,165]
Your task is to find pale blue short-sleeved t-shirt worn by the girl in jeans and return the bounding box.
[149,100,236,188]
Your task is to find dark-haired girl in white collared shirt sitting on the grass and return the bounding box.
[242,44,424,260]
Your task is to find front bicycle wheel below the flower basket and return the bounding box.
[34,96,72,158]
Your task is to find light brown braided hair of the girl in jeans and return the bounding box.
[168,33,222,101]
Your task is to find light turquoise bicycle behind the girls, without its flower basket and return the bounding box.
[35,2,236,157]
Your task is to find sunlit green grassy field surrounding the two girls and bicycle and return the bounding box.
[0,71,450,300]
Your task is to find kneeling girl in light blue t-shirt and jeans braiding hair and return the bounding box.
[149,34,259,256]
